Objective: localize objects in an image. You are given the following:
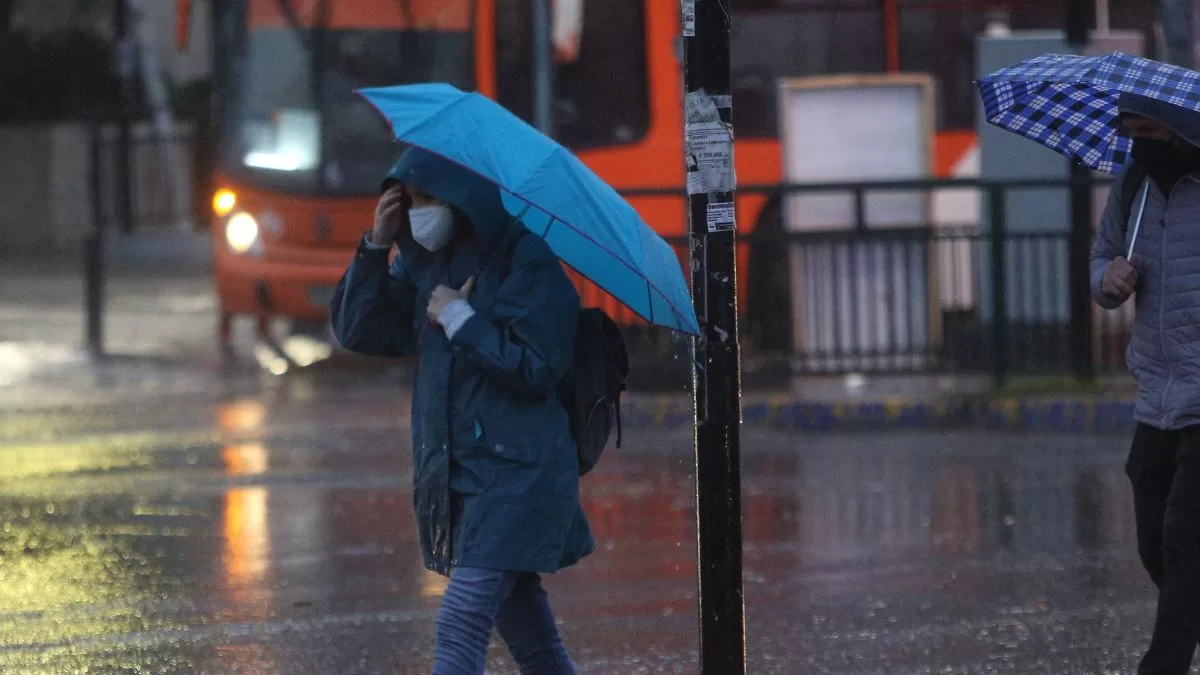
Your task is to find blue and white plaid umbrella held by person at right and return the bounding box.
[978,52,1200,174]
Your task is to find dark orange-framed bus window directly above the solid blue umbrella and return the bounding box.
[496,0,650,150]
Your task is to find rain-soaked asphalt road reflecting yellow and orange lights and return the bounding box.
[0,366,1180,675]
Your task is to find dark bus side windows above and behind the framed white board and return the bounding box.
[731,0,1156,138]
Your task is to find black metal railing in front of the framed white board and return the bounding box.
[623,179,1133,380]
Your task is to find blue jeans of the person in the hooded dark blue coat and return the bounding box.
[433,567,575,675]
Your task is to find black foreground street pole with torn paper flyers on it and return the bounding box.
[682,0,745,675]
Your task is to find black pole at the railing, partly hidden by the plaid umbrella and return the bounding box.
[1064,0,1096,381]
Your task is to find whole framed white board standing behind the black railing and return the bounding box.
[780,76,938,362]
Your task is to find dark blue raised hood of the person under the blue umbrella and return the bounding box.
[383,148,516,249]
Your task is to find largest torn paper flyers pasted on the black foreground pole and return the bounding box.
[684,89,737,195]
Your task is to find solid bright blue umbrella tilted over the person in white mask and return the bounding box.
[359,84,700,335]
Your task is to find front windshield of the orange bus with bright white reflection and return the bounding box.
[222,0,474,196]
